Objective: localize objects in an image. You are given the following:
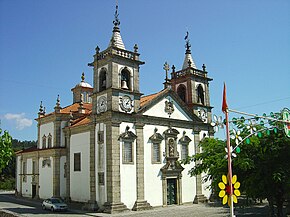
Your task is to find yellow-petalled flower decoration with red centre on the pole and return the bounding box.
[218,175,241,206]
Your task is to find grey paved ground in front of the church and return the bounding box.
[0,192,274,217]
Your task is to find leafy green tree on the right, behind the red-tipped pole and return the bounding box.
[183,114,290,216]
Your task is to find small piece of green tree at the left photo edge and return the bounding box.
[0,128,13,173]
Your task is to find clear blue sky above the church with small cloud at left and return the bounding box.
[0,0,290,140]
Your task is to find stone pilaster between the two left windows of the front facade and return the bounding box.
[132,124,152,211]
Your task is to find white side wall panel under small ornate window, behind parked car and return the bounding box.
[39,157,53,199]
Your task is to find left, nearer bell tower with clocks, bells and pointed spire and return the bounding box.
[88,5,144,114]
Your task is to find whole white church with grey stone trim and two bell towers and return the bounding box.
[16,5,214,213]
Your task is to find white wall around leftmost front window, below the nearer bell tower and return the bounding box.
[120,122,137,209]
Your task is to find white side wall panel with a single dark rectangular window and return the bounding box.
[70,132,90,202]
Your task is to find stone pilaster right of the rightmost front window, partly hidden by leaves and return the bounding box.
[193,129,207,203]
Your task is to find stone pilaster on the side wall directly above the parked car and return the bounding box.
[52,153,60,197]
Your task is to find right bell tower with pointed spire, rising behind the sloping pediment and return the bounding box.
[170,32,213,123]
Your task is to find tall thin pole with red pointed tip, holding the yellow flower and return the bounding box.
[222,83,235,217]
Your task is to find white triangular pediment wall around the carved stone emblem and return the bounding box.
[144,96,191,121]
